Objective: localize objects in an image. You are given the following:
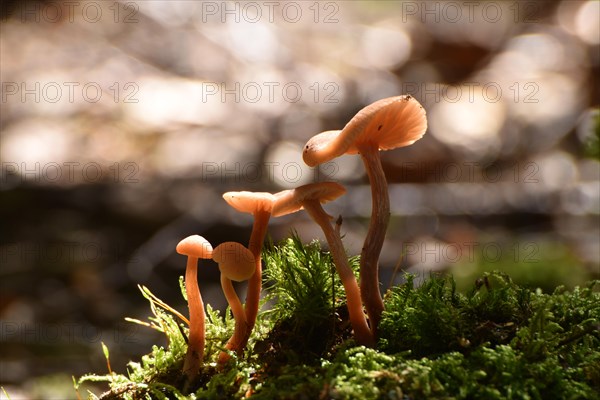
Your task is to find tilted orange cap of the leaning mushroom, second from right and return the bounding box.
[273,182,346,217]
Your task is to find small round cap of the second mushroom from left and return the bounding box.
[212,242,255,282]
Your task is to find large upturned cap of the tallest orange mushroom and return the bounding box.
[302,95,427,167]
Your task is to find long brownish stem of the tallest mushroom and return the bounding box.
[359,146,390,336]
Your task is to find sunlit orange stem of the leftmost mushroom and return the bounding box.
[183,256,205,381]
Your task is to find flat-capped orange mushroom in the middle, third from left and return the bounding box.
[223,191,275,347]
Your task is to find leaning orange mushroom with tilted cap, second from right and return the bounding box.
[273,182,374,346]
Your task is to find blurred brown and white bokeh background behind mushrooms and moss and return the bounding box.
[0,0,600,399]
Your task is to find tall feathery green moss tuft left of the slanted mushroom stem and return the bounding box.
[256,235,359,372]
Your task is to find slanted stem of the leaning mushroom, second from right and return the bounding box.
[302,200,374,347]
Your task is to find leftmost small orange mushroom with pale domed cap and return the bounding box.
[176,235,213,381]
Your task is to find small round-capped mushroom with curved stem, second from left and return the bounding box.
[212,242,255,364]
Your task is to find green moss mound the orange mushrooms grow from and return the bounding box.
[79,237,600,399]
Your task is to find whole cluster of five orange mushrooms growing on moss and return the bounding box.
[176,95,427,379]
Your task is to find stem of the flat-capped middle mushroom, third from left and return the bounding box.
[242,211,271,340]
